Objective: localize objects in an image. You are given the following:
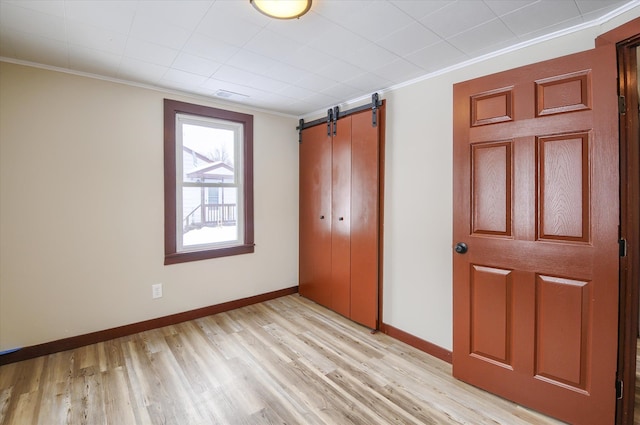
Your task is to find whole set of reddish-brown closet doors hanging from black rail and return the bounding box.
[299,100,385,329]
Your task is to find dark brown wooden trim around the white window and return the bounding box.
[164,99,255,265]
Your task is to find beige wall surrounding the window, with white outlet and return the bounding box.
[0,63,298,350]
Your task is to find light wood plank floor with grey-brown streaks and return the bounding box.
[0,295,560,425]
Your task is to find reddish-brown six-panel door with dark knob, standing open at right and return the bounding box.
[453,47,619,425]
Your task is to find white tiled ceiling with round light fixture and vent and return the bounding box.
[0,0,640,116]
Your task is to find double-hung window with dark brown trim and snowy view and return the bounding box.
[164,99,254,264]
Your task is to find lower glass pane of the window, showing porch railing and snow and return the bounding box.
[180,187,241,250]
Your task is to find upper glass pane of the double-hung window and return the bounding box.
[182,123,235,183]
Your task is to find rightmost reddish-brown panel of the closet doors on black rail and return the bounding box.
[351,111,379,329]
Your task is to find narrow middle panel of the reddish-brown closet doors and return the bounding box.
[331,116,351,317]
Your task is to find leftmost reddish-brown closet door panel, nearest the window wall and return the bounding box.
[299,121,331,307]
